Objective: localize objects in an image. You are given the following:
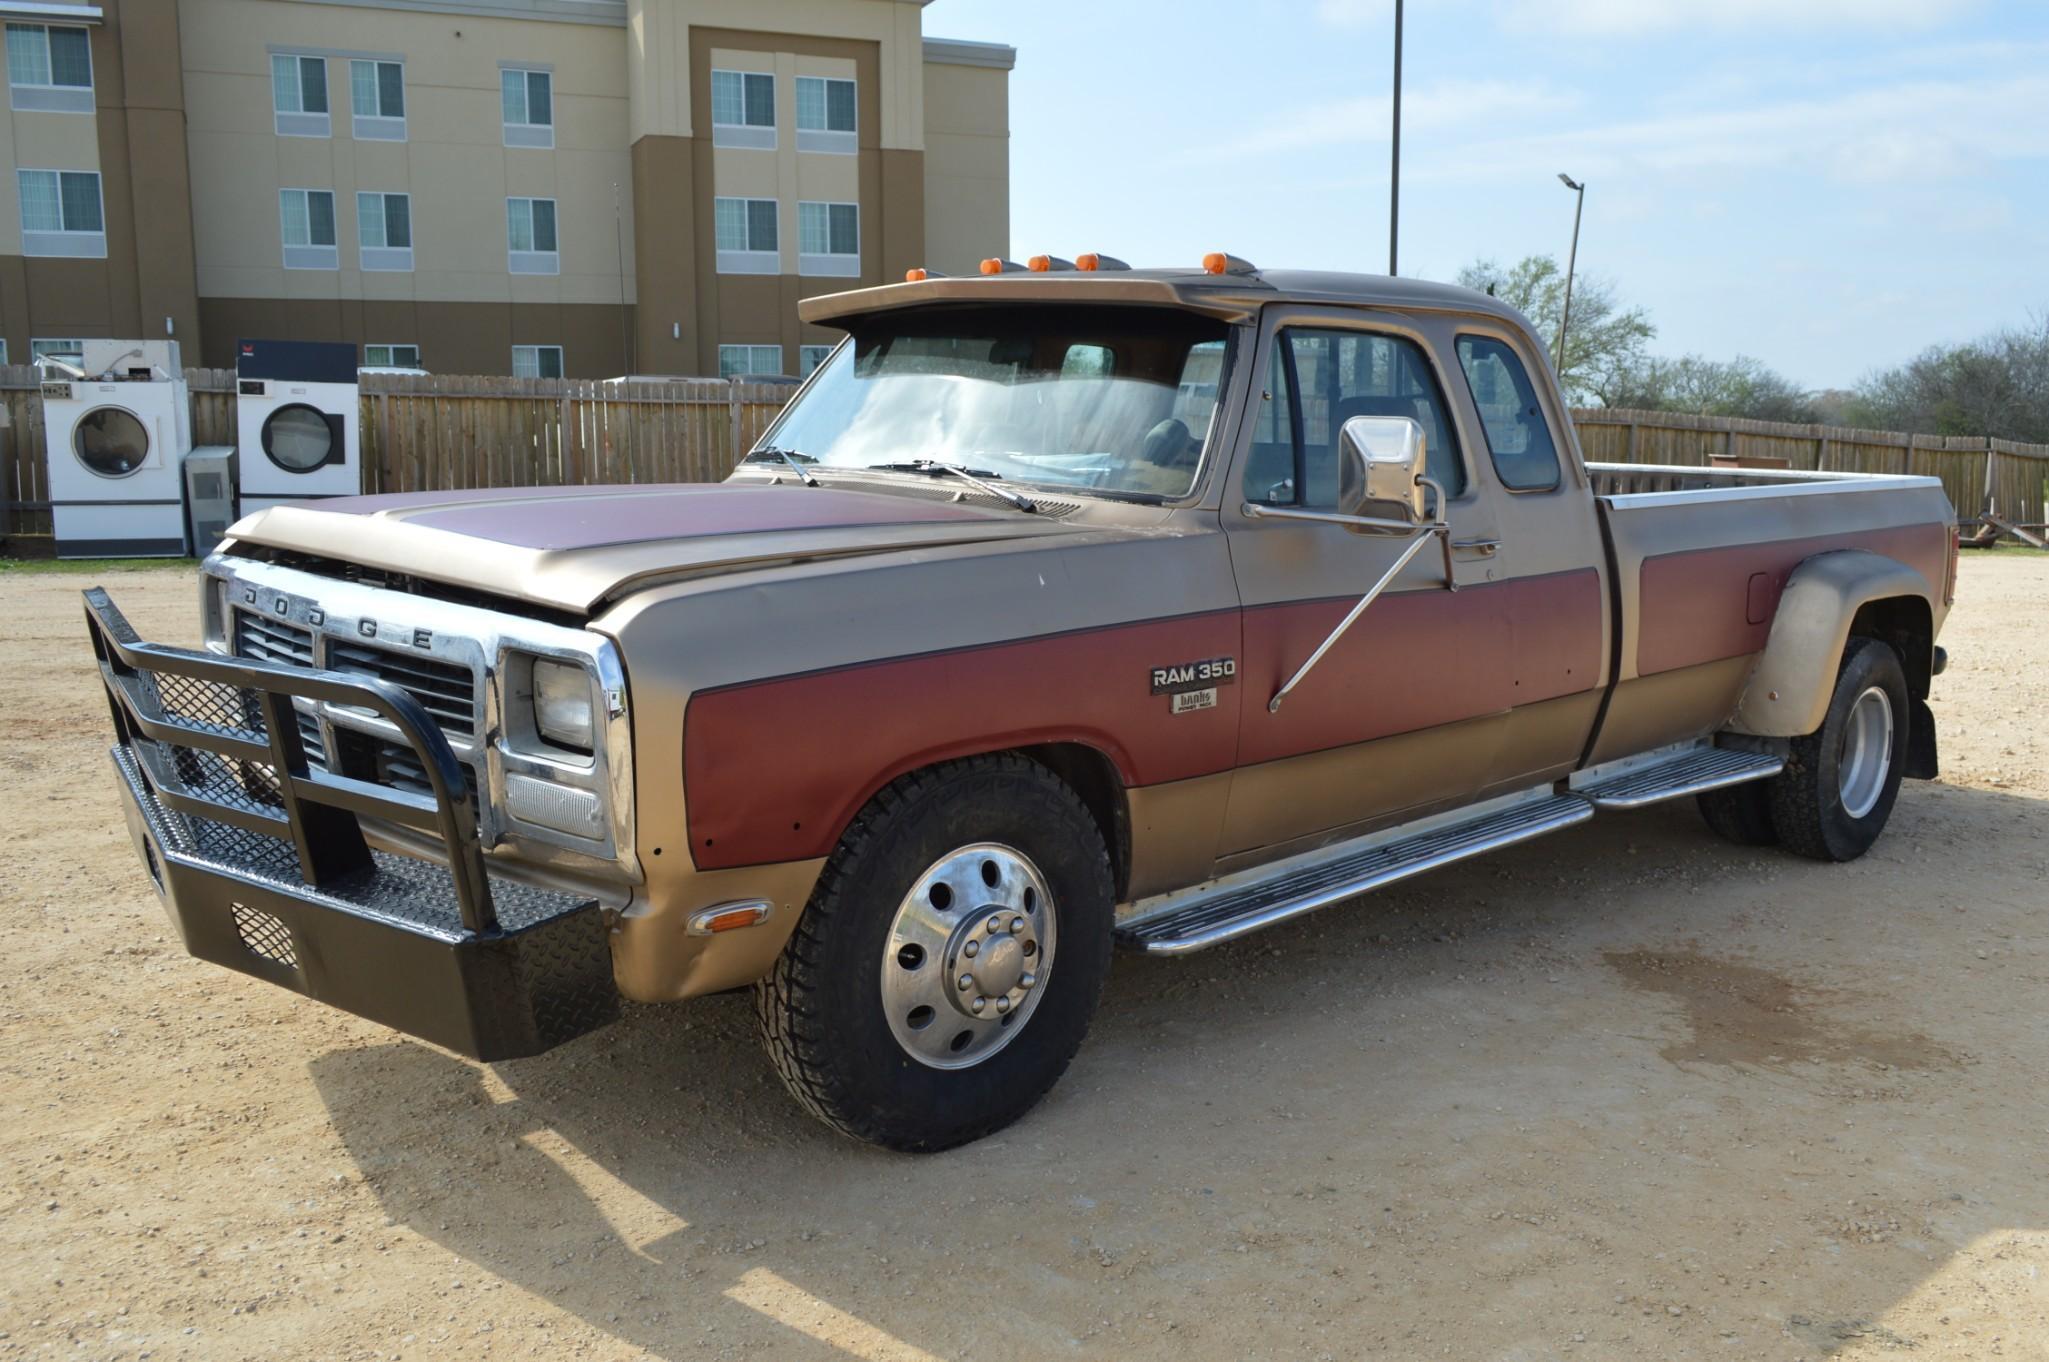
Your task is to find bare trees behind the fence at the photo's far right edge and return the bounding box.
[1842,313,2049,442]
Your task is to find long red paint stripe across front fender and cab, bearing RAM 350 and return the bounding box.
[684,569,1606,870]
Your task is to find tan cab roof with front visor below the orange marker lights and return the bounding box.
[797,270,1531,332]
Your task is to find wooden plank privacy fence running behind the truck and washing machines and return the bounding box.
[0,374,2049,535]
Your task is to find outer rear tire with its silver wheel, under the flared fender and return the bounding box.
[1770,637,1910,860]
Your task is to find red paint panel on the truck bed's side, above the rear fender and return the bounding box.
[1637,524,1949,676]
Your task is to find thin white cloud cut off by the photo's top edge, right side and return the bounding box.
[1499,0,1979,37]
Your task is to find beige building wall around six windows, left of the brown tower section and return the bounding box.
[180,0,633,307]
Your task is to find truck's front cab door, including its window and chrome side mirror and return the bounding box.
[1221,307,1512,868]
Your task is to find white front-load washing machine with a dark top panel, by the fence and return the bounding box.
[236,340,363,516]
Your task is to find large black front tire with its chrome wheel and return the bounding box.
[754,756,1115,1151]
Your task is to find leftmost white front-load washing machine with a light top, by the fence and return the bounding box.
[41,340,193,557]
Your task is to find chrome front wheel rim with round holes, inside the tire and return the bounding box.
[881,842,1055,1069]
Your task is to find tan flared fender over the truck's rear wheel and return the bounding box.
[1729,549,1934,737]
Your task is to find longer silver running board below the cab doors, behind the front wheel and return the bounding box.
[1117,791,1594,954]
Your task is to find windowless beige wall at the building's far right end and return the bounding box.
[924,61,1008,274]
